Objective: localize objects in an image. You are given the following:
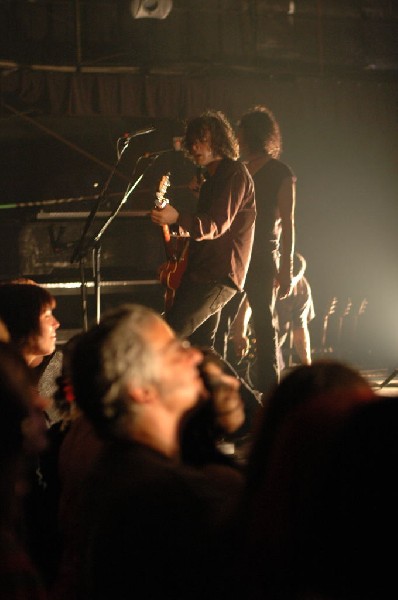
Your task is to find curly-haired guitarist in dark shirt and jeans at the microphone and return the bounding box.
[151,111,256,347]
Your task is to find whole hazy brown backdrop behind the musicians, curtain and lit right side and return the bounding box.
[0,70,398,363]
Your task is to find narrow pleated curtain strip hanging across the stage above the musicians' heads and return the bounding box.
[1,68,398,120]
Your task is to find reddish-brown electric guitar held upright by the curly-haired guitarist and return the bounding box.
[155,173,189,312]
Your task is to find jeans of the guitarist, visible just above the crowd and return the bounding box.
[165,278,237,347]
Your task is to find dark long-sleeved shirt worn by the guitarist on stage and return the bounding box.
[178,158,256,290]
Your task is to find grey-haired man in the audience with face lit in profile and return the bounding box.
[60,305,241,600]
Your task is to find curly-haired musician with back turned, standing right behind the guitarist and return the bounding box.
[238,106,296,393]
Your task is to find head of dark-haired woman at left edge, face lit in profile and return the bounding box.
[0,282,59,366]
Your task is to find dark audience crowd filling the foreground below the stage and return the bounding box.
[0,284,398,600]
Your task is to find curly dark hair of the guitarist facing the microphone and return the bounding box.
[184,110,239,160]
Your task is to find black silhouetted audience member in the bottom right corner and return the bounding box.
[306,397,398,600]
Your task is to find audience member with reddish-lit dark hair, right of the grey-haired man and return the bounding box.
[238,361,377,600]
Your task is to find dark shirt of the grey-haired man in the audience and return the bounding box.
[76,442,241,600]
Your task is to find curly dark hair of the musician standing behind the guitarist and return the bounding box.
[238,105,282,158]
